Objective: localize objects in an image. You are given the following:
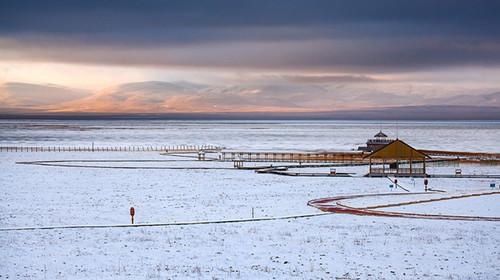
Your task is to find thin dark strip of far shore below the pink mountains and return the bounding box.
[0,106,500,121]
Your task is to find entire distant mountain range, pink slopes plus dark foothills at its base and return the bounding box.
[0,81,500,120]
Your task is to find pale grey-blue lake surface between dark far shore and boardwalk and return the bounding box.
[0,120,500,152]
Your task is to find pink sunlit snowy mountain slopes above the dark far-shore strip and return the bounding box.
[0,81,500,113]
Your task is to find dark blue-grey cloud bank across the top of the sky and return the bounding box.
[0,0,500,71]
